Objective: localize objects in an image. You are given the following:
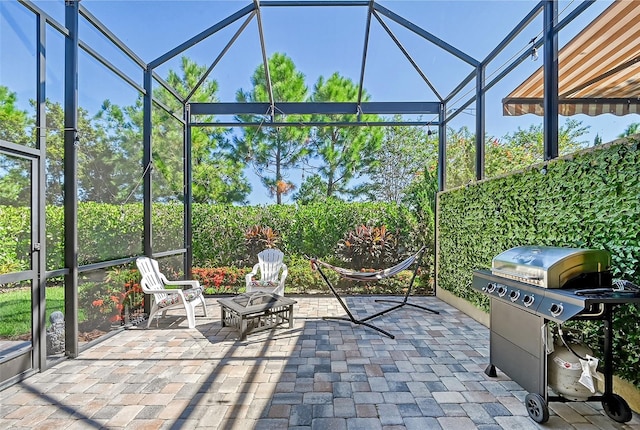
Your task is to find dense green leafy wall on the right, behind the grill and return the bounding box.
[437,140,640,386]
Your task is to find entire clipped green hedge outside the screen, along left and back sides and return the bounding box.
[0,201,420,273]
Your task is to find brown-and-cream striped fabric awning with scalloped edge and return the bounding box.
[502,0,640,116]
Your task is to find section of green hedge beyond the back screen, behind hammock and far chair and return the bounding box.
[193,201,419,267]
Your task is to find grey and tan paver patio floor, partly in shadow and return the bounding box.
[0,296,640,430]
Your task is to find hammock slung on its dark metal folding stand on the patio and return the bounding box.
[311,248,440,339]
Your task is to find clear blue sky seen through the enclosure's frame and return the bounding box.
[0,0,638,203]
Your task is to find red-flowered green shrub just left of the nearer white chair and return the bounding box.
[78,268,144,328]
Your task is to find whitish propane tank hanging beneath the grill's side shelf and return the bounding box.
[547,339,593,401]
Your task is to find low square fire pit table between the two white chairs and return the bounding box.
[218,293,297,340]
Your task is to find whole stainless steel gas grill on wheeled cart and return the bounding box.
[472,246,640,423]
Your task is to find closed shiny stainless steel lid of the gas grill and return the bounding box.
[491,246,611,288]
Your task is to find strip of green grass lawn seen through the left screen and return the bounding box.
[0,287,64,339]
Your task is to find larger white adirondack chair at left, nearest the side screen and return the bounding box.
[136,257,207,328]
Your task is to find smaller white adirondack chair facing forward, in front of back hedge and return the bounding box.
[245,249,288,296]
